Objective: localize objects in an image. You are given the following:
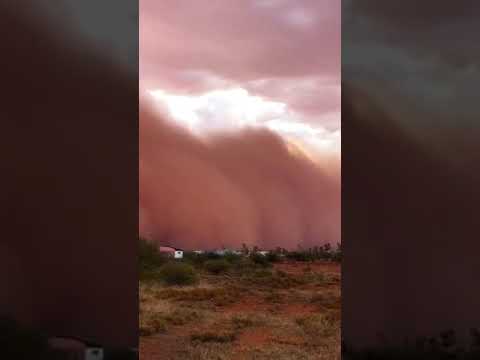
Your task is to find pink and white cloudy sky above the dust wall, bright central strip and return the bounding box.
[139,0,341,155]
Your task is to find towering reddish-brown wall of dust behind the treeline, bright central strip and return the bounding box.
[139,100,340,249]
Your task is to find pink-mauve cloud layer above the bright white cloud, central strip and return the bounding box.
[140,0,340,128]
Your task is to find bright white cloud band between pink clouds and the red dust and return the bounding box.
[149,88,340,153]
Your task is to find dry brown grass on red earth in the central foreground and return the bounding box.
[140,263,341,360]
